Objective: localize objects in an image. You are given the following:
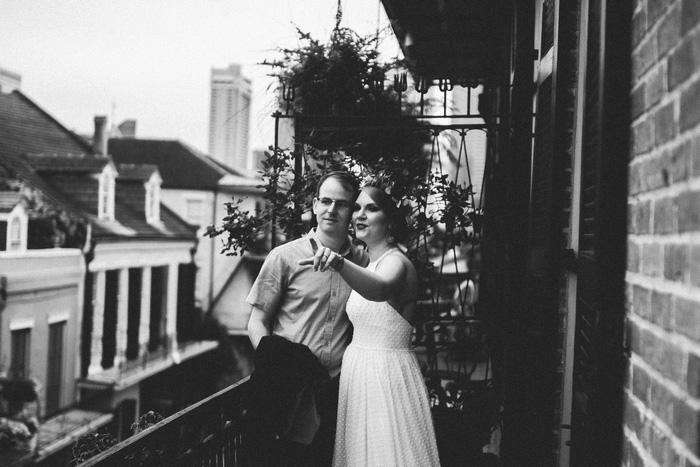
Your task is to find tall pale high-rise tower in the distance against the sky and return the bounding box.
[209,64,255,172]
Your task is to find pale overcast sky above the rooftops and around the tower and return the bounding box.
[0,0,399,152]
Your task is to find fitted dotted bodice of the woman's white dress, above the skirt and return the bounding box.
[346,249,413,350]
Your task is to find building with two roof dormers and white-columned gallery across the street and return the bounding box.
[0,90,218,465]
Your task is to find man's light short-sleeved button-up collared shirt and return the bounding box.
[246,232,369,377]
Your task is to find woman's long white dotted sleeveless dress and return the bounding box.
[333,250,440,467]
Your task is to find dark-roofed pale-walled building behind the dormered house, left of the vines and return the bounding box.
[109,138,263,334]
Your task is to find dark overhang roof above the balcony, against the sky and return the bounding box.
[382,0,508,84]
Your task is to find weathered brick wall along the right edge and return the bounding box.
[624,0,700,467]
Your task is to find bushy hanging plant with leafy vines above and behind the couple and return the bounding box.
[206,22,471,266]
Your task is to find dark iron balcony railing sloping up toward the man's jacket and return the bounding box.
[80,378,248,467]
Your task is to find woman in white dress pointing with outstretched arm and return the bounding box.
[299,186,439,467]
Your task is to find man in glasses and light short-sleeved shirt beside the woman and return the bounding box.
[246,172,368,466]
